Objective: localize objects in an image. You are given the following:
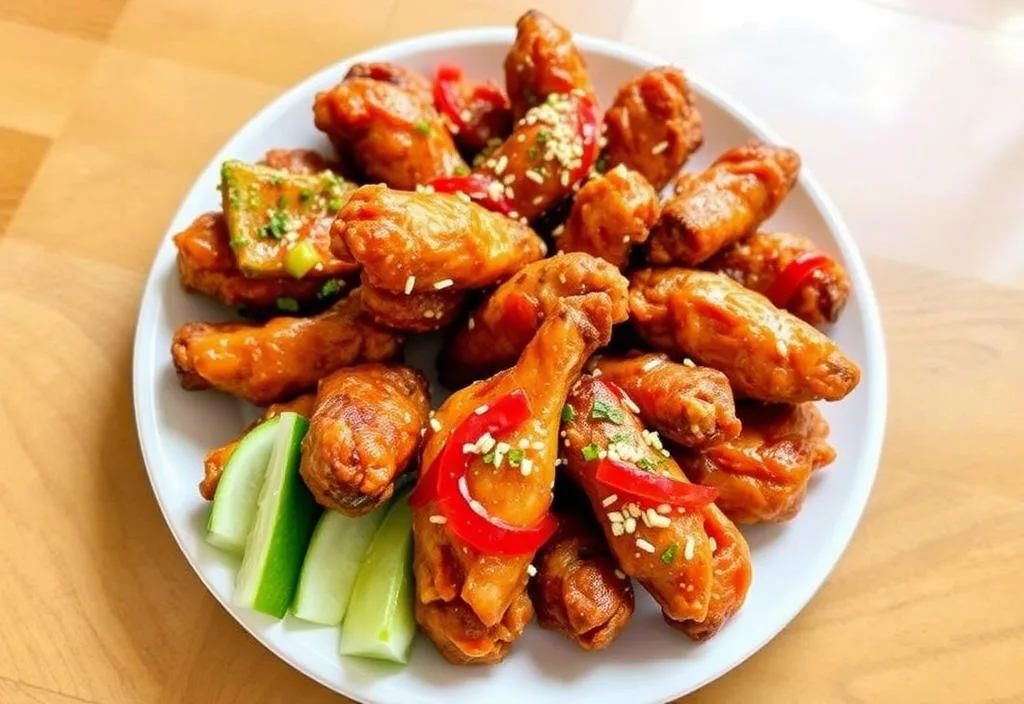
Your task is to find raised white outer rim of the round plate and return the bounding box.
[132,26,889,704]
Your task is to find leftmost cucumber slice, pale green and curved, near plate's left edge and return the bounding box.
[206,417,279,556]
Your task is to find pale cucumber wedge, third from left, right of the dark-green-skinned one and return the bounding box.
[292,507,387,626]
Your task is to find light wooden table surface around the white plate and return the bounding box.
[0,0,1024,704]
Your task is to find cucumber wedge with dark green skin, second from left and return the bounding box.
[233,412,319,618]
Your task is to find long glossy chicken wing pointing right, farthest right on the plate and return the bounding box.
[630,268,860,403]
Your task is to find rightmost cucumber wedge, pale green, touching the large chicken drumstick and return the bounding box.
[339,494,416,663]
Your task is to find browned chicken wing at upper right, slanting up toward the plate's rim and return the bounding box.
[647,139,800,265]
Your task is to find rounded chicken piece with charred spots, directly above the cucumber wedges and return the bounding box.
[299,363,430,516]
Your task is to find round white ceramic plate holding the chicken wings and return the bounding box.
[133,29,886,704]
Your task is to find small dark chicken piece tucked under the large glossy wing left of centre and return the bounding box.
[352,272,466,333]
